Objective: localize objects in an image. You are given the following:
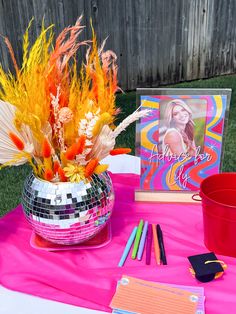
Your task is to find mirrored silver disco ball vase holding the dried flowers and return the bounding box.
[22,172,114,245]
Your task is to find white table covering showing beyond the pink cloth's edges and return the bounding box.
[0,155,140,314]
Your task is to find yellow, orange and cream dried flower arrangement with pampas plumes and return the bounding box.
[0,17,148,182]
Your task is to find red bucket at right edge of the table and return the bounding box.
[199,172,236,257]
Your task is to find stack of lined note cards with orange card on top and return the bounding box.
[110,276,204,314]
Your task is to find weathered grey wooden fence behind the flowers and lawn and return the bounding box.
[0,0,236,90]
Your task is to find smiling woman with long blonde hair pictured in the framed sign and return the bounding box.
[162,99,196,156]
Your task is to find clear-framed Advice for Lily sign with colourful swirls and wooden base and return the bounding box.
[135,88,232,203]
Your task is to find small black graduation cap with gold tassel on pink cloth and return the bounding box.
[188,252,224,282]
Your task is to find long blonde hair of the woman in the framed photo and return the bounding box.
[165,99,195,150]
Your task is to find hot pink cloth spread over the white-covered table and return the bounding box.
[0,175,236,314]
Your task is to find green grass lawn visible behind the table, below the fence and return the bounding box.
[0,75,236,215]
